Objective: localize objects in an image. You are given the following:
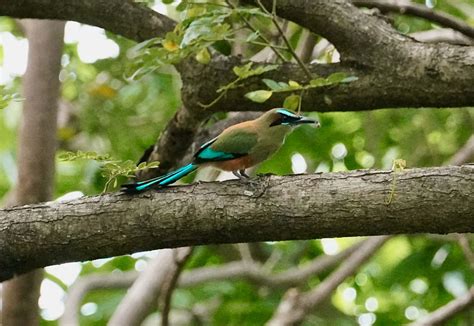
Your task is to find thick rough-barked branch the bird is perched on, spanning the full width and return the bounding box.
[0,165,474,280]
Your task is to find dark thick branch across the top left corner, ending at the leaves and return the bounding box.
[0,0,175,42]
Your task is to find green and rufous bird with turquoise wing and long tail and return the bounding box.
[122,108,319,193]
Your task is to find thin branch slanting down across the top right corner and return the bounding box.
[352,0,474,38]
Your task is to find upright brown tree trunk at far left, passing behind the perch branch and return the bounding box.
[2,21,64,325]
